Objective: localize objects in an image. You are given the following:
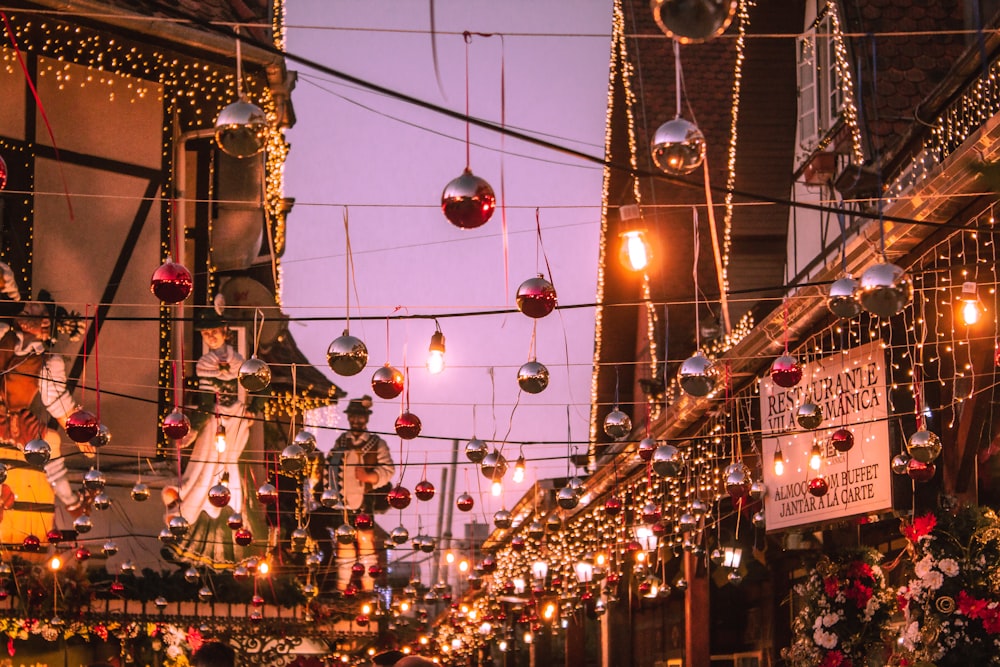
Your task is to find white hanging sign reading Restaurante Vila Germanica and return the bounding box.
[760,343,892,531]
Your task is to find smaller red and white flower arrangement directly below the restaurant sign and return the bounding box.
[782,549,894,667]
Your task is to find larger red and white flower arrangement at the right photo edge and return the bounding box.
[896,507,1000,667]
